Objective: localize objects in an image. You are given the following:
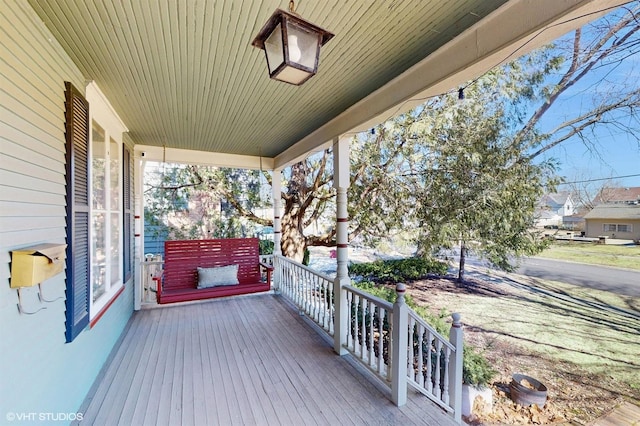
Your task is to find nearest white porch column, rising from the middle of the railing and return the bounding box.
[333,138,350,355]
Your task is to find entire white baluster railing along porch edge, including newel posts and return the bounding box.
[274,256,463,423]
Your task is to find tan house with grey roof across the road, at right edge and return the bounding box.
[584,204,640,240]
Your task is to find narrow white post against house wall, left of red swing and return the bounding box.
[133,155,146,311]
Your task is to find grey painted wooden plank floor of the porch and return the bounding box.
[80,295,455,425]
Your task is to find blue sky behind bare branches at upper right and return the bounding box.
[541,5,640,189]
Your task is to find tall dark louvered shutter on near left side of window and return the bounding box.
[64,81,91,343]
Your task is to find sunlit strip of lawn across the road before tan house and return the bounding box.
[538,242,640,271]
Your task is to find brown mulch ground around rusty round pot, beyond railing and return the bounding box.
[408,278,640,425]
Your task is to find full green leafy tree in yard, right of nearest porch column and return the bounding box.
[407,78,554,281]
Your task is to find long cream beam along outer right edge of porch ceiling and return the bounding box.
[274,0,628,169]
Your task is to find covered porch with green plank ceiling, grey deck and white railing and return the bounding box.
[0,0,624,424]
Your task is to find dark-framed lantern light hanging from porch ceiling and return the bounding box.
[251,1,333,86]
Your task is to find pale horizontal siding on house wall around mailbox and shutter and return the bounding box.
[0,0,133,424]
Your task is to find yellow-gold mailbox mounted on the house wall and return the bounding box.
[11,244,67,288]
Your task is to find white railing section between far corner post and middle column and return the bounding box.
[273,256,334,336]
